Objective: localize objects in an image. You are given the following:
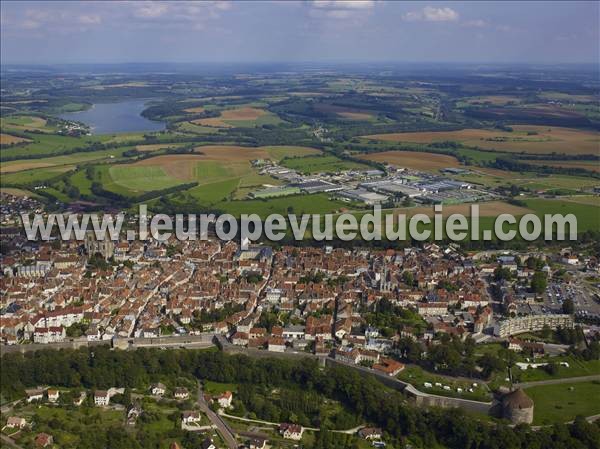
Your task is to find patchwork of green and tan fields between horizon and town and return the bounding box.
[0,63,600,229]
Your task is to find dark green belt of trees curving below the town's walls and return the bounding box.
[0,347,600,449]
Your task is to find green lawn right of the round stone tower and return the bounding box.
[525,382,600,425]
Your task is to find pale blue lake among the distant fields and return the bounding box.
[59,100,165,134]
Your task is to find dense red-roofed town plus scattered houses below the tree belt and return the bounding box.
[0,187,600,447]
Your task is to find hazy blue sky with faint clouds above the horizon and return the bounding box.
[0,0,600,64]
